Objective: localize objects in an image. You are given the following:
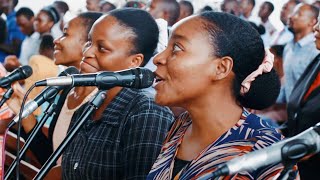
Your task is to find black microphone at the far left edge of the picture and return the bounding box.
[0,66,32,88]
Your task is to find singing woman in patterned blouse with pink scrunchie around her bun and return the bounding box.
[147,12,298,179]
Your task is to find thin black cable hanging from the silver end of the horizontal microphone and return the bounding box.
[16,84,36,180]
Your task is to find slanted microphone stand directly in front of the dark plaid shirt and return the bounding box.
[34,90,106,180]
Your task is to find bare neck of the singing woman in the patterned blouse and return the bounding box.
[182,88,242,143]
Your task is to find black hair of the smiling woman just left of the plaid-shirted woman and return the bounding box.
[77,11,103,40]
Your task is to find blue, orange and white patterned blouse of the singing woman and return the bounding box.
[147,110,296,180]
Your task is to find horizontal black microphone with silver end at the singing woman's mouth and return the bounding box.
[35,68,154,89]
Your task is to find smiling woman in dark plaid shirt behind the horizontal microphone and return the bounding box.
[62,8,173,180]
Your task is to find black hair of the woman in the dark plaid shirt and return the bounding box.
[108,8,159,66]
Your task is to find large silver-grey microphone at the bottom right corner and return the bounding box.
[210,123,320,178]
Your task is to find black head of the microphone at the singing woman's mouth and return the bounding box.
[134,67,155,89]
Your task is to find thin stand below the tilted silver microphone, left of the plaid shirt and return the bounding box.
[4,103,56,179]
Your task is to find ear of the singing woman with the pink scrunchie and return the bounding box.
[213,56,233,80]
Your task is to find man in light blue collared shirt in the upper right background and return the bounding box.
[277,4,320,103]
